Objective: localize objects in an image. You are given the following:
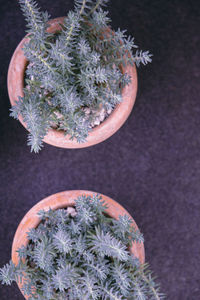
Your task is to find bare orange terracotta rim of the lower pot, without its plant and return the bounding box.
[12,190,145,299]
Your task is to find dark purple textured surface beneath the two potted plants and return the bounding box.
[0,0,200,300]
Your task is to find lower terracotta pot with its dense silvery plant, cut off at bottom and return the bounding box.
[0,191,163,300]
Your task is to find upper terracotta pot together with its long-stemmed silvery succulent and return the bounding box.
[8,0,151,152]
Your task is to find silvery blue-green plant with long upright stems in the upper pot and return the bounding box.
[11,0,151,152]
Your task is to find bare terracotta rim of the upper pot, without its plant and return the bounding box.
[8,17,137,148]
